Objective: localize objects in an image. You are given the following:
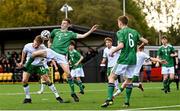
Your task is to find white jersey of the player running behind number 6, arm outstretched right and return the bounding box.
[134,52,150,76]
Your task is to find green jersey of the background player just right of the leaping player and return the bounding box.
[69,49,82,69]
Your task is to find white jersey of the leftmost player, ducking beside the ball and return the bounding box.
[23,43,48,68]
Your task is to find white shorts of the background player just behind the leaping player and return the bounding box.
[71,67,84,77]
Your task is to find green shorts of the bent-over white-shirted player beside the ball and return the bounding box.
[27,65,49,75]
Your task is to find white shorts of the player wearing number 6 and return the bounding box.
[112,64,136,78]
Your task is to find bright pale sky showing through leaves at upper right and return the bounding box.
[139,0,180,32]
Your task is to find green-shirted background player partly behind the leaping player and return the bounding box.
[68,42,84,94]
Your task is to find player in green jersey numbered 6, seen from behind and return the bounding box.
[101,16,148,107]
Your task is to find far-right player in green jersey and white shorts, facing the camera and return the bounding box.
[156,35,177,93]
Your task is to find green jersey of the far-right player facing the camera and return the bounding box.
[157,44,175,67]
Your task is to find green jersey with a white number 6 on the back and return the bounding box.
[117,27,140,65]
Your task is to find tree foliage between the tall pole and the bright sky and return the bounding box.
[125,0,157,45]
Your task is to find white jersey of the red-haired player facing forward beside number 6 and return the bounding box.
[103,46,120,67]
